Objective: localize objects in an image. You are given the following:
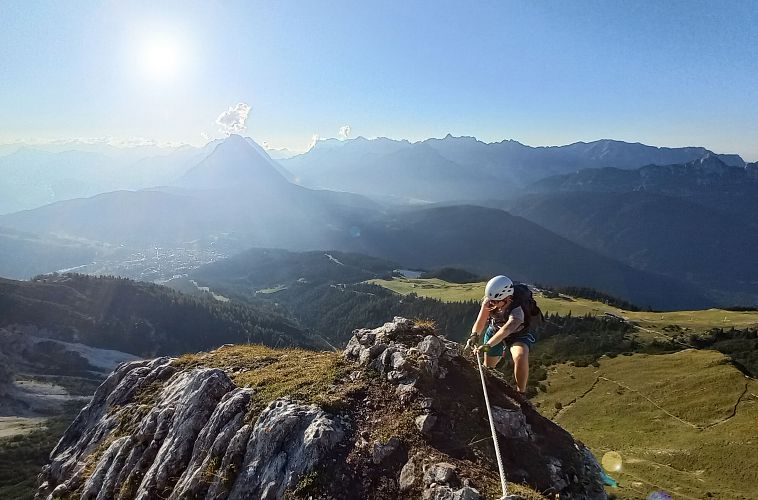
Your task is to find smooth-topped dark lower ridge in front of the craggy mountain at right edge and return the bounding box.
[504,191,758,294]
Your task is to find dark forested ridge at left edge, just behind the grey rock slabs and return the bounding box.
[0,274,326,357]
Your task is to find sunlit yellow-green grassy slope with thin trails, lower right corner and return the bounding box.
[535,350,758,499]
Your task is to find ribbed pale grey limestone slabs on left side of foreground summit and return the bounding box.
[36,358,344,500]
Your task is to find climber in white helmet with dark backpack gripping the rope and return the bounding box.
[466,276,541,394]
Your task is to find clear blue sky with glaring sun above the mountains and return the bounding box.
[0,0,758,161]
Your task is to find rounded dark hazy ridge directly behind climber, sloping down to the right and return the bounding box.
[332,206,711,309]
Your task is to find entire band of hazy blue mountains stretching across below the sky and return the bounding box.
[0,135,758,308]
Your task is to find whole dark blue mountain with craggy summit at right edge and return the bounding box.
[498,155,758,304]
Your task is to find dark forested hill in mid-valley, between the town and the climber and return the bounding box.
[192,249,486,346]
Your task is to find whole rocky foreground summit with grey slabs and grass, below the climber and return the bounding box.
[37,318,605,500]
